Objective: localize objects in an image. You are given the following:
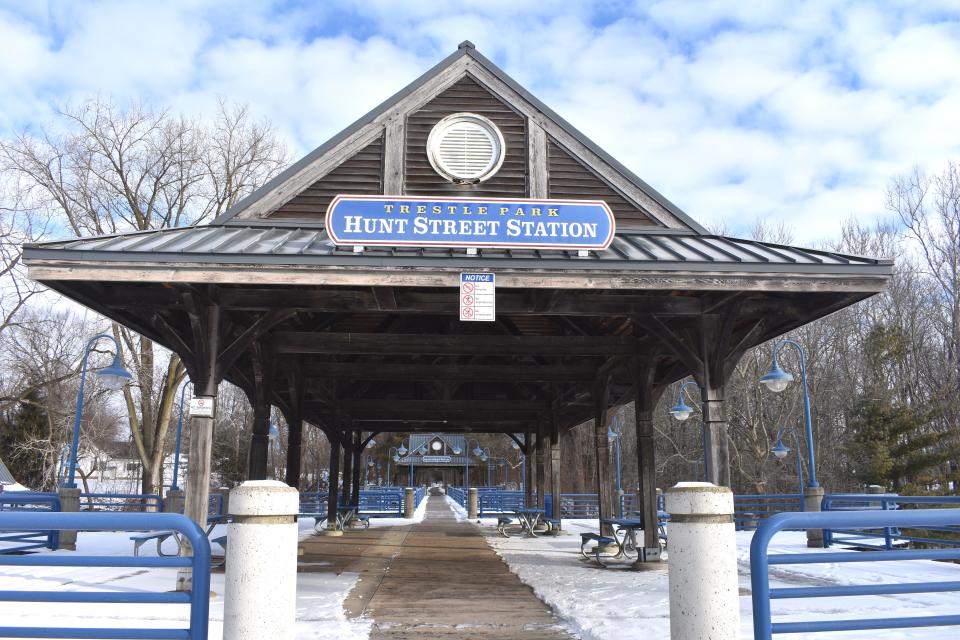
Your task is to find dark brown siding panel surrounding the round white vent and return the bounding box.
[404,76,527,198]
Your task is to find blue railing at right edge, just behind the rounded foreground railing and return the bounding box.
[820,493,960,550]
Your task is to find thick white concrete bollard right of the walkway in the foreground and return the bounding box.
[666,482,740,640]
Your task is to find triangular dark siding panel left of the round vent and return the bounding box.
[269,136,383,219]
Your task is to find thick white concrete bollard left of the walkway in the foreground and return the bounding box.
[223,480,300,640]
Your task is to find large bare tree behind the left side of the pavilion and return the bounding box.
[0,99,286,493]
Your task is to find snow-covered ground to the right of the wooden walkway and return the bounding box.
[484,505,960,640]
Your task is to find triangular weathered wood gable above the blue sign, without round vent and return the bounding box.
[242,46,703,232]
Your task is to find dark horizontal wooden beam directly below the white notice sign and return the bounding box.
[272,331,634,356]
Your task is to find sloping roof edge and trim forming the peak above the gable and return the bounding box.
[213,41,707,233]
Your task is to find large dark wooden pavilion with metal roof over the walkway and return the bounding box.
[24,42,892,548]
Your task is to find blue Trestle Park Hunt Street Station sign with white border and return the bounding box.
[326,195,616,249]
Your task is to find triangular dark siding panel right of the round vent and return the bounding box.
[547,138,657,227]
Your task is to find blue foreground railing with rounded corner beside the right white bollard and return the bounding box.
[750,509,960,640]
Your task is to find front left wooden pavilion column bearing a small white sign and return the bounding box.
[184,304,221,528]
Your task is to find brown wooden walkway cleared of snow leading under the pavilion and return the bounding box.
[300,496,573,640]
